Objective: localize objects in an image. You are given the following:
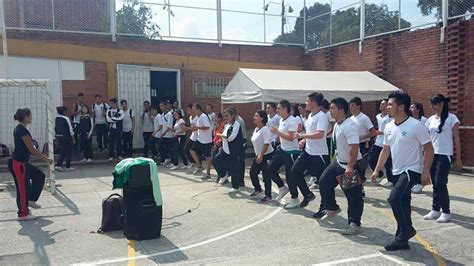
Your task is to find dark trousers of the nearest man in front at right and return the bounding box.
[388,170,421,240]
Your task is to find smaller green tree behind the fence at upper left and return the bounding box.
[116,2,161,39]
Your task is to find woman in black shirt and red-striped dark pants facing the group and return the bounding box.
[8,108,53,221]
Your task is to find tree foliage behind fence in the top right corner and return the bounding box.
[418,0,474,19]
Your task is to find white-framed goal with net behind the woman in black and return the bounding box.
[0,80,56,193]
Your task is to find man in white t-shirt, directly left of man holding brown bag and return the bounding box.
[285,92,329,209]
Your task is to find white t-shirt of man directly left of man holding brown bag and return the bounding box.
[304,111,330,156]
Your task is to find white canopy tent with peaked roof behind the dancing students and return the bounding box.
[221,68,399,108]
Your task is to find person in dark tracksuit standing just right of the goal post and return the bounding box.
[54,106,75,171]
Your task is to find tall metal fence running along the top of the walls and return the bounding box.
[3,0,474,51]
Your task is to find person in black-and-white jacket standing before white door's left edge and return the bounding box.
[106,98,124,162]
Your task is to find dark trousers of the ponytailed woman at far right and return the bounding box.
[430,154,451,214]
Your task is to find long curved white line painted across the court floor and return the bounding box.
[73,205,283,265]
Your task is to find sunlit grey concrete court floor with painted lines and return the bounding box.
[0,161,474,265]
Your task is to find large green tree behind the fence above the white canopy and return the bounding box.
[274,3,411,48]
